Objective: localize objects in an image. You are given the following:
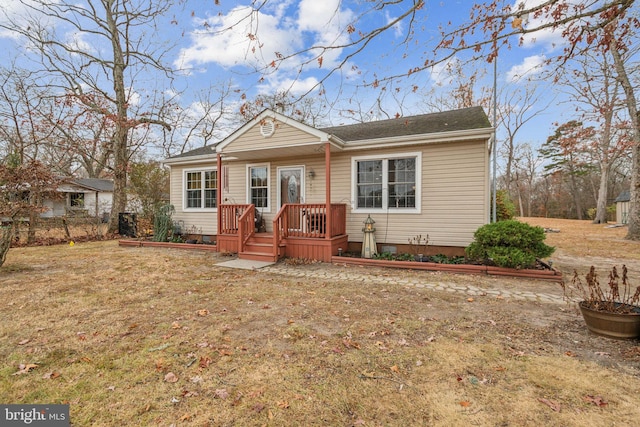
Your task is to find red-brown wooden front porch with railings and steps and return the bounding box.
[217,203,348,262]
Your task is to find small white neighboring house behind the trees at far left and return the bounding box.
[40,178,113,218]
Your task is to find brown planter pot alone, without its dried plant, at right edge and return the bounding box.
[578,301,640,339]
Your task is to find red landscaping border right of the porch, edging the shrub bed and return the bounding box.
[331,256,562,282]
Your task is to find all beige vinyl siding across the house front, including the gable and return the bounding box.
[171,135,490,247]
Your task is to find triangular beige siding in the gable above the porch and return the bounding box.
[224,122,318,154]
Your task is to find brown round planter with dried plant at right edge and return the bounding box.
[561,265,640,339]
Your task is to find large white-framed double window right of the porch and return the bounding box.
[353,153,421,212]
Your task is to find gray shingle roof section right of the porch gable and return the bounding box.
[320,107,491,142]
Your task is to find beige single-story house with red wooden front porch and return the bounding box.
[164,107,493,261]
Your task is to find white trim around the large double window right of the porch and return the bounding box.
[351,151,422,214]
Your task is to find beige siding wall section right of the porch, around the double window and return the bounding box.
[331,141,489,246]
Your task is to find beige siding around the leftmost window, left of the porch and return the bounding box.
[170,159,218,235]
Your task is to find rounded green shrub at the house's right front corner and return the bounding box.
[466,220,555,268]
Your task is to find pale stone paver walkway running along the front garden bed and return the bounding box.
[260,263,565,304]
